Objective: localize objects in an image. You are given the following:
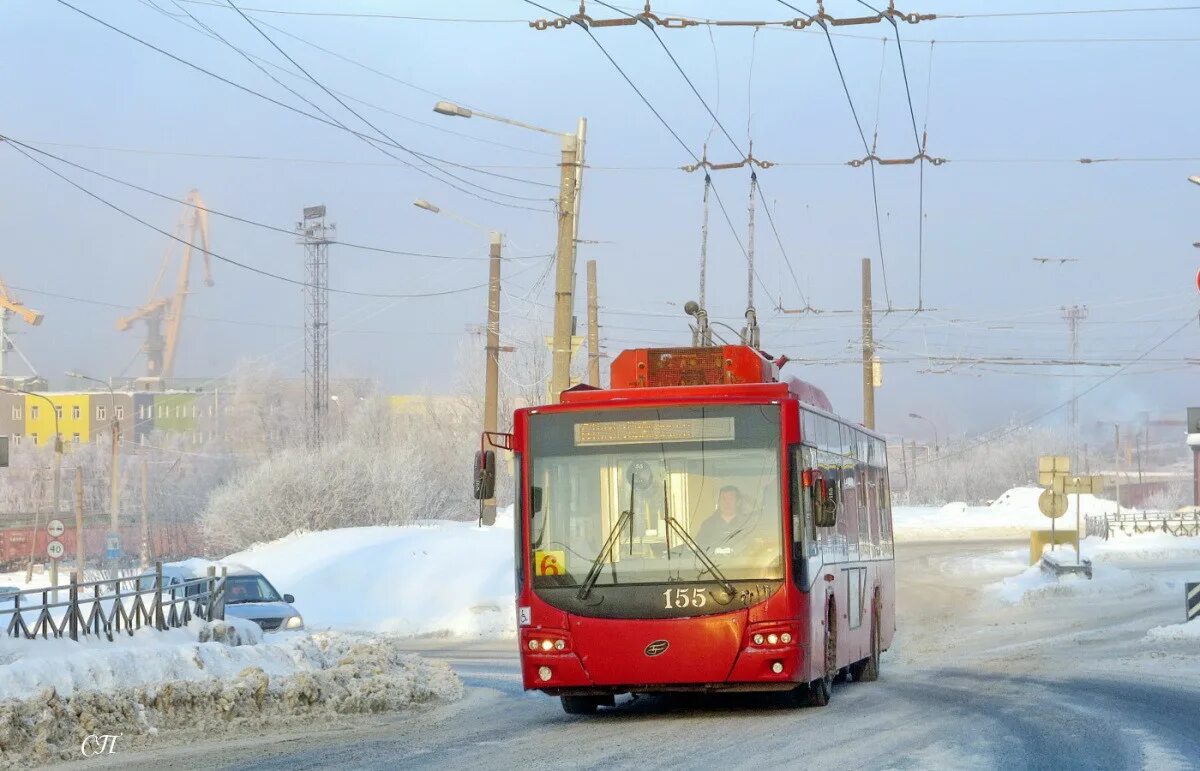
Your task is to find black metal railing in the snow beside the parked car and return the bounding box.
[0,562,224,643]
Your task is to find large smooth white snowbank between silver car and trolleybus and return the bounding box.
[226,512,516,638]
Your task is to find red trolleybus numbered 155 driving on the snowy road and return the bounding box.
[476,346,895,713]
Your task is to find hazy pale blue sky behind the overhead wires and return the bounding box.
[0,0,1200,437]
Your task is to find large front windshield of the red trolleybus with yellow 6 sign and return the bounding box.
[528,405,784,600]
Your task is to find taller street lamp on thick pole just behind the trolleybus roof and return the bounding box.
[432,101,588,401]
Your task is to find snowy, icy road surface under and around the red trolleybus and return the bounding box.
[77,542,1200,771]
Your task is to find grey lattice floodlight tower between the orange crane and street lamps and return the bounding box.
[296,204,337,449]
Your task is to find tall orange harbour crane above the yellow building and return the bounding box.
[116,190,212,378]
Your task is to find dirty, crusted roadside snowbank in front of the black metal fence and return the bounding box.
[0,624,463,767]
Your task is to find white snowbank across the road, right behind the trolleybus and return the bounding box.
[892,488,1117,540]
